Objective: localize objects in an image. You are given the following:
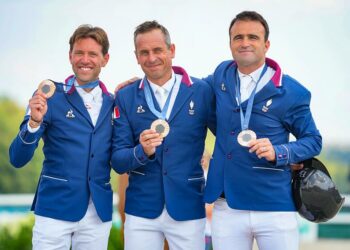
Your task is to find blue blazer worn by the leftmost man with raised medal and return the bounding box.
[9,76,114,222]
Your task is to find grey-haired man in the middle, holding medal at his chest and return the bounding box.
[112,21,215,250]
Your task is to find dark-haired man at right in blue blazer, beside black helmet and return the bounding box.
[205,11,322,250]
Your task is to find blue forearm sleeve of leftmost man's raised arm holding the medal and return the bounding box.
[9,114,47,168]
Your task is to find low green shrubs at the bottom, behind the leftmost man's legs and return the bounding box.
[0,215,124,250]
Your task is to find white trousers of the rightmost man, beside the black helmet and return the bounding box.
[212,198,299,250]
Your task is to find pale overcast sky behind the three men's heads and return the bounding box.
[0,0,350,144]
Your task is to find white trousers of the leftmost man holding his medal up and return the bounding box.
[33,202,112,250]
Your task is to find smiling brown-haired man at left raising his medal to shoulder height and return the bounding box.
[9,25,114,250]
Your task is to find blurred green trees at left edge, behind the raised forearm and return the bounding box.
[0,97,43,193]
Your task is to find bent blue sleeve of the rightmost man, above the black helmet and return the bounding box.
[274,91,322,166]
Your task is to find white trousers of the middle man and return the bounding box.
[124,208,205,250]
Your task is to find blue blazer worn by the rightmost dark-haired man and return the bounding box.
[205,59,322,211]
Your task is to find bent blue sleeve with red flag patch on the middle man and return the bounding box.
[111,93,151,174]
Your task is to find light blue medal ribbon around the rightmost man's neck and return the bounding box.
[235,64,267,131]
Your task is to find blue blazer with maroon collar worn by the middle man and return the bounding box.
[112,67,215,221]
